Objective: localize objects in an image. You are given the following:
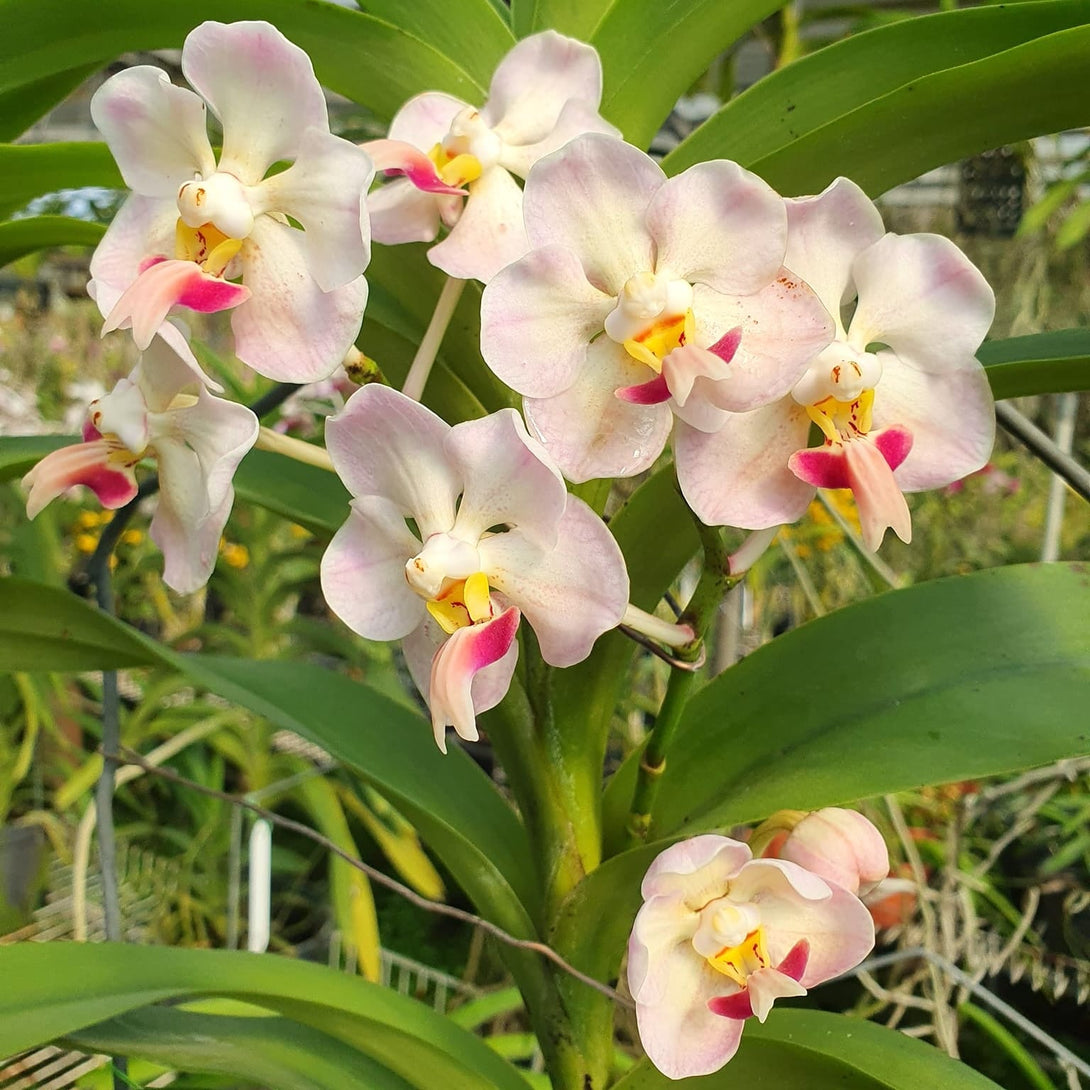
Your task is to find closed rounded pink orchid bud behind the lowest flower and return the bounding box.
[777,807,889,893]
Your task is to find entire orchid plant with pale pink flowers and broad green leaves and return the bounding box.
[0,6,1086,1090]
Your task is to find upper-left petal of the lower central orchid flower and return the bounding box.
[326,385,463,538]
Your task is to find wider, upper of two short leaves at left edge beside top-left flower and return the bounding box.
[0,143,125,222]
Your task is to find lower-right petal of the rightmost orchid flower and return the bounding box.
[874,352,995,492]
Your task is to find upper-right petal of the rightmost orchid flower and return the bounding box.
[849,234,995,374]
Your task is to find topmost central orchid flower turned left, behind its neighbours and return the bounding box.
[363,31,619,282]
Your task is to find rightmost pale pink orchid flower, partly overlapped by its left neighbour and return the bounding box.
[676,178,995,550]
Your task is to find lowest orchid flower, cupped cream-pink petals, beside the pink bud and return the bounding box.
[628,835,874,1079]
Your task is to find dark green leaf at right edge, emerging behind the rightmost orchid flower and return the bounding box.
[977,329,1090,400]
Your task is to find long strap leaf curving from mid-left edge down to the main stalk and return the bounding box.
[0,579,533,937]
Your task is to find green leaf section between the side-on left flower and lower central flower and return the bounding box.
[233,446,349,537]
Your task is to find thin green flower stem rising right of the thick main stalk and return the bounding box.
[627,522,742,847]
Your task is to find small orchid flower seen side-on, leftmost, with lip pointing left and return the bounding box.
[23,337,258,594]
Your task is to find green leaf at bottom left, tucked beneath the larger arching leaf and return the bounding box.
[68,1007,413,1090]
